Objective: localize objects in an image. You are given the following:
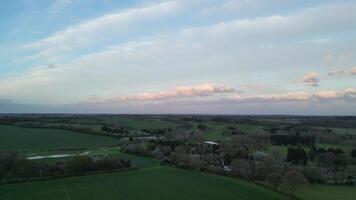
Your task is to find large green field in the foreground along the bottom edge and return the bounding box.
[0,167,290,200]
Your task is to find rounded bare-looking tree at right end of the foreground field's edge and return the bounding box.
[282,170,307,198]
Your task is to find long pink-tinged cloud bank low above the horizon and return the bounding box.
[88,83,356,105]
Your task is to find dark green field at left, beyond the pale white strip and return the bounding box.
[0,125,117,150]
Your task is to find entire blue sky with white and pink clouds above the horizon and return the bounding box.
[0,0,356,115]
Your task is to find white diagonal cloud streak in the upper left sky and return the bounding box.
[22,0,180,61]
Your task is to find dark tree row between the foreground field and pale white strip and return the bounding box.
[0,152,132,183]
